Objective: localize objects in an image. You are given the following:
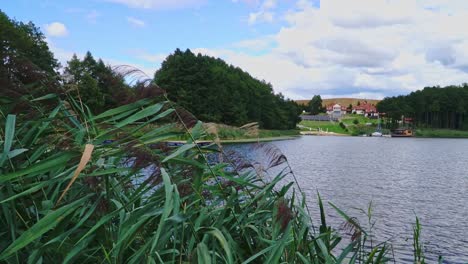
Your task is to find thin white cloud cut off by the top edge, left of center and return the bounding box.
[105,0,206,9]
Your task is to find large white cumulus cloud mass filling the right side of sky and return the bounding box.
[187,0,468,99]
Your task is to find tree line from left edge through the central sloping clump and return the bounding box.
[0,10,301,129]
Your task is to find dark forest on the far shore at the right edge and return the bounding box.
[377,84,468,130]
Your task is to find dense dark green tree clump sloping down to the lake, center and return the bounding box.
[154,49,300,129]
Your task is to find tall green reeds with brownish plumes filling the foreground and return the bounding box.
[0,88,424,263]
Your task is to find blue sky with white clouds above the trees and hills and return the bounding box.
[0,0,468,99]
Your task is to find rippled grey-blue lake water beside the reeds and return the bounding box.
[229,136,468,263]
